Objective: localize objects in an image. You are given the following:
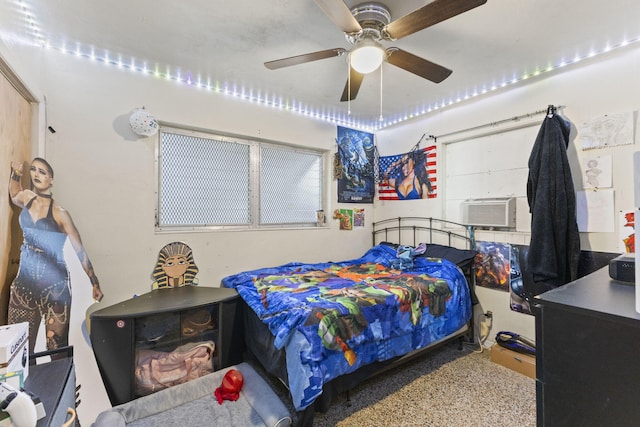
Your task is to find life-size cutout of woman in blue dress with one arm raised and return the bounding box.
[8,157,103,358]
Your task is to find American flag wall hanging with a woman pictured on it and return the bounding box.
[378,144,438,200]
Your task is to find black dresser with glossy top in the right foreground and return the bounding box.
[535,267,640,427]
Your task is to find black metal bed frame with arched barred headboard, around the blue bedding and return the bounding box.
[243,217,475,427]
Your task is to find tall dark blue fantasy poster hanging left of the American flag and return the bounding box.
[334,126,375,203]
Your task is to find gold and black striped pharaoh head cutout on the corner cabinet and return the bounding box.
[151,242,198,289]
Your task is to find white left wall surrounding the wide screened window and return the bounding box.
[0,44,373,423]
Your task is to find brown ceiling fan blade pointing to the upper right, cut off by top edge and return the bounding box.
[384,0,487,40]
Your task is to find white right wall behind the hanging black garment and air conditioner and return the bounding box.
[375,47,640,352]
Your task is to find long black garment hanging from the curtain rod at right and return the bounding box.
[525,113,580,295]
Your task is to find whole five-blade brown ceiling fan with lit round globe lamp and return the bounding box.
[264,0,487,101]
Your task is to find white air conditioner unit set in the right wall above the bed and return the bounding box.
[462,197,516,228]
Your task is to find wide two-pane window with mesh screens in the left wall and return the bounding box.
[156,127,324,230]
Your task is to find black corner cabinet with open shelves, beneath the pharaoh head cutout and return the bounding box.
[90,286,244,406]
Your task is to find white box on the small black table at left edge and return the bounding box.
[0,322,29,388]
